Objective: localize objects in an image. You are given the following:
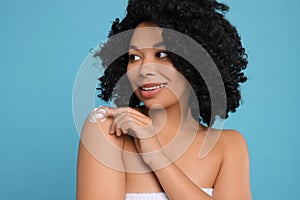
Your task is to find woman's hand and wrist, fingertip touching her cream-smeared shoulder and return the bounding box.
[103,107,167,169]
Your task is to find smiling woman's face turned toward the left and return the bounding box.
[127,22,189,108]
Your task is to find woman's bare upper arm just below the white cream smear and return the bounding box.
[77,114,126,200]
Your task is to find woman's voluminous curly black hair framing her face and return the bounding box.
[95,0,248,126]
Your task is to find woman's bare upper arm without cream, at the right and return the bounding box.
[214,131,251,200]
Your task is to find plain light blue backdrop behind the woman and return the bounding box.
[0,0,300,200]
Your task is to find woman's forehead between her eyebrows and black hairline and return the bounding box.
[130,24,163,49]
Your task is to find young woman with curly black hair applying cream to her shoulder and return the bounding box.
[77,0,251,200]
